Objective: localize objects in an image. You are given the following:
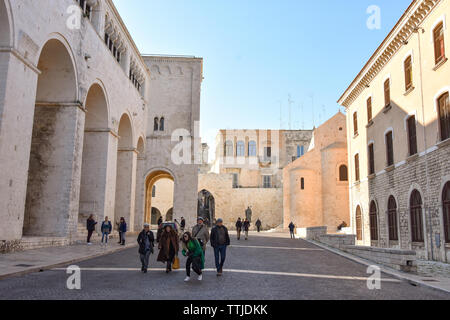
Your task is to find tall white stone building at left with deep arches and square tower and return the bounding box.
[0,0,202,252]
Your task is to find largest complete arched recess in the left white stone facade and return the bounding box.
[23,39,77,237]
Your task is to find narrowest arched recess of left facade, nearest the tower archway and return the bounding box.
[114,114,136,232]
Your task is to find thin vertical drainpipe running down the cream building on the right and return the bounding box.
[414,27,434,261]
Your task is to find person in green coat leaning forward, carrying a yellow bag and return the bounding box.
[182,232,205,282]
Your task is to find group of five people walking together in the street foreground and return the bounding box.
[137,217,230,282]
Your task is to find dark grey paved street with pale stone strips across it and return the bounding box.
[0,234,450,300]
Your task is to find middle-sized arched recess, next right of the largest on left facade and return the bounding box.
[78,84,110,226]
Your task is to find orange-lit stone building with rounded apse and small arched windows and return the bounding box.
[283,113,350,232]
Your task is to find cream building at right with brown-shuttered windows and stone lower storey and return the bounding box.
[339,0,450,262]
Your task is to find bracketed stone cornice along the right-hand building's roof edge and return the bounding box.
[338,0,442,108]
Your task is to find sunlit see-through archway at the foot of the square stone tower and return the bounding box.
[144,170,175,225]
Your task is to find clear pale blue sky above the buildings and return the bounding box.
[114,0,411,160]
